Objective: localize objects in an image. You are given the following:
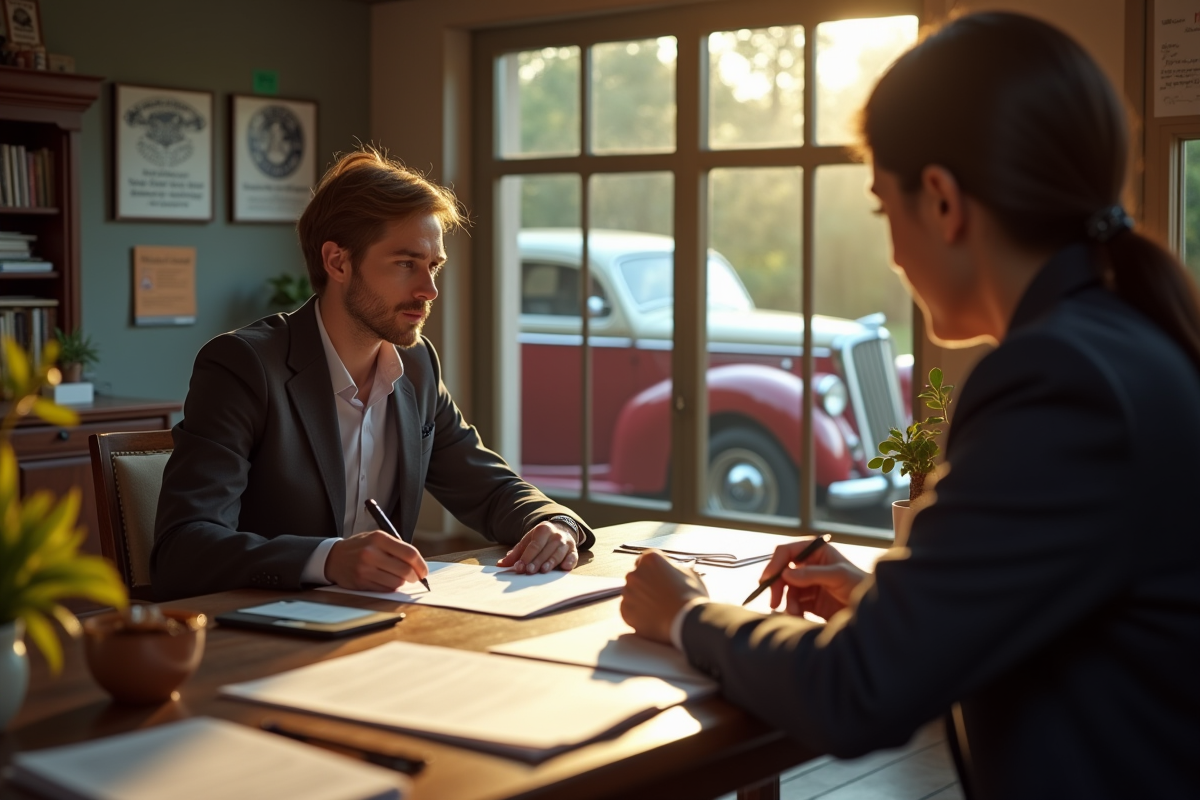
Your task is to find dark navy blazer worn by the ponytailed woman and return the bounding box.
[683,245,1200,800]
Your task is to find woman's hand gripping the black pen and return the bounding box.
[762,540,866,619]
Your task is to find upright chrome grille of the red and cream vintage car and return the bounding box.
[841,332,908,457]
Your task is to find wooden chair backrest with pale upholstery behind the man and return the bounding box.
[89,431,175,600]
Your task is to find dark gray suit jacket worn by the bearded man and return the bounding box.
[150,300,594,600]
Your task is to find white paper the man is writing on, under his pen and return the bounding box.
[322,561,625,618]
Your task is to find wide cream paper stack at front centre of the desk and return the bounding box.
[221,642,706,763]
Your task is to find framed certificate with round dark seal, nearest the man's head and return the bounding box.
[229,95,317,223]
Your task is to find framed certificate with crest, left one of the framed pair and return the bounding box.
[113,84,212,222]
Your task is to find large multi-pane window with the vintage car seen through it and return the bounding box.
[474,0,920,536]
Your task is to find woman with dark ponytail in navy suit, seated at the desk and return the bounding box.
[622,13,1200,799]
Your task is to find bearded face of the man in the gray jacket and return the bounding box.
[346,215,446,348]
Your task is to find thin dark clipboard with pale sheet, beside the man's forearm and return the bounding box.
[217,599,404,639]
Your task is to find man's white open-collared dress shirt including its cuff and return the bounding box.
[300,300,404,584]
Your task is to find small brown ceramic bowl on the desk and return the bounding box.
[83,609,208,705]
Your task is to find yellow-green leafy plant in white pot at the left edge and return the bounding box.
[0,337,127,730]
